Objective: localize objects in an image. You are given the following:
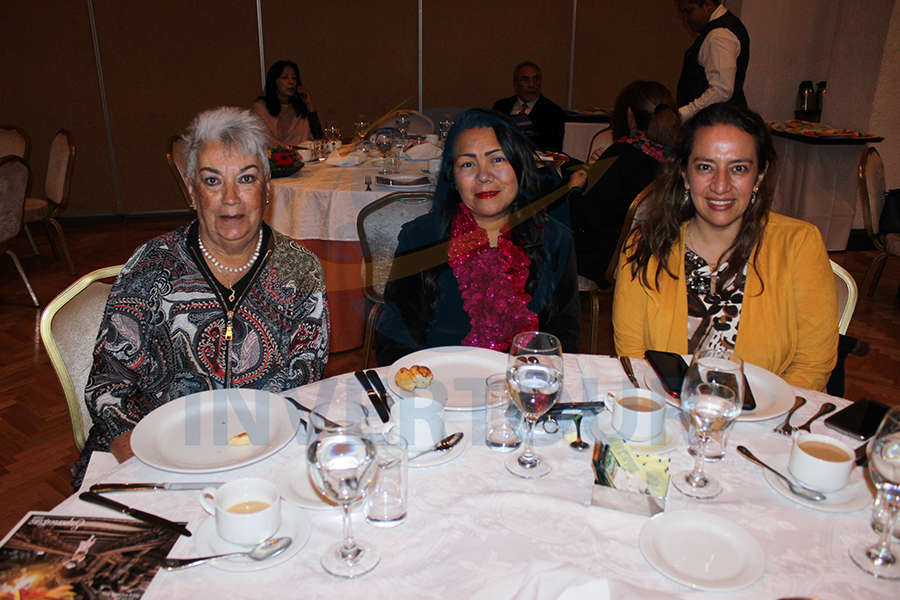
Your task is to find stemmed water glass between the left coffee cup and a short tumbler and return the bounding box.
[306,406,381,578]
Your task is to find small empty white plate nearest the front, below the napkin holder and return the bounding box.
[639,510,766,592]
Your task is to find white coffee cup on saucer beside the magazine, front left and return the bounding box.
[200,477,281,546]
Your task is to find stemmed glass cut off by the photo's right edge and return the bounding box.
[850,406,900,579]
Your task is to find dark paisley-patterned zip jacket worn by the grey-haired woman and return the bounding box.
[73,225,329,481]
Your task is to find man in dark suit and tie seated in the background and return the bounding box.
[494,61,566,152]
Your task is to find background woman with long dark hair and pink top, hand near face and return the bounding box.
[251,60,322,147]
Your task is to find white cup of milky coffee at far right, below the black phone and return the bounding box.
[788,431,854,492]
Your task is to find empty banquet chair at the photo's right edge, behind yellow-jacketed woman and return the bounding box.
[857,148,900,298]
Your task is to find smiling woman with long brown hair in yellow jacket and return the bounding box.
[613,104,838,390]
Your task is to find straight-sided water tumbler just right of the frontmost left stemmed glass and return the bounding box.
[364,430,409,527]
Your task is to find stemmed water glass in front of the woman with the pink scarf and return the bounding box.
[506,331,563,479]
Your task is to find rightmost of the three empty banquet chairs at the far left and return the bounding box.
[25,129,75,275]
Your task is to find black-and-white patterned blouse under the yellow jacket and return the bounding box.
[684,248,747,354]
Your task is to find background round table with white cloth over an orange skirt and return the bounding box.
[265,154,436,352]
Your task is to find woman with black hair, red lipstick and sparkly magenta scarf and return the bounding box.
[376,110,579,364]
